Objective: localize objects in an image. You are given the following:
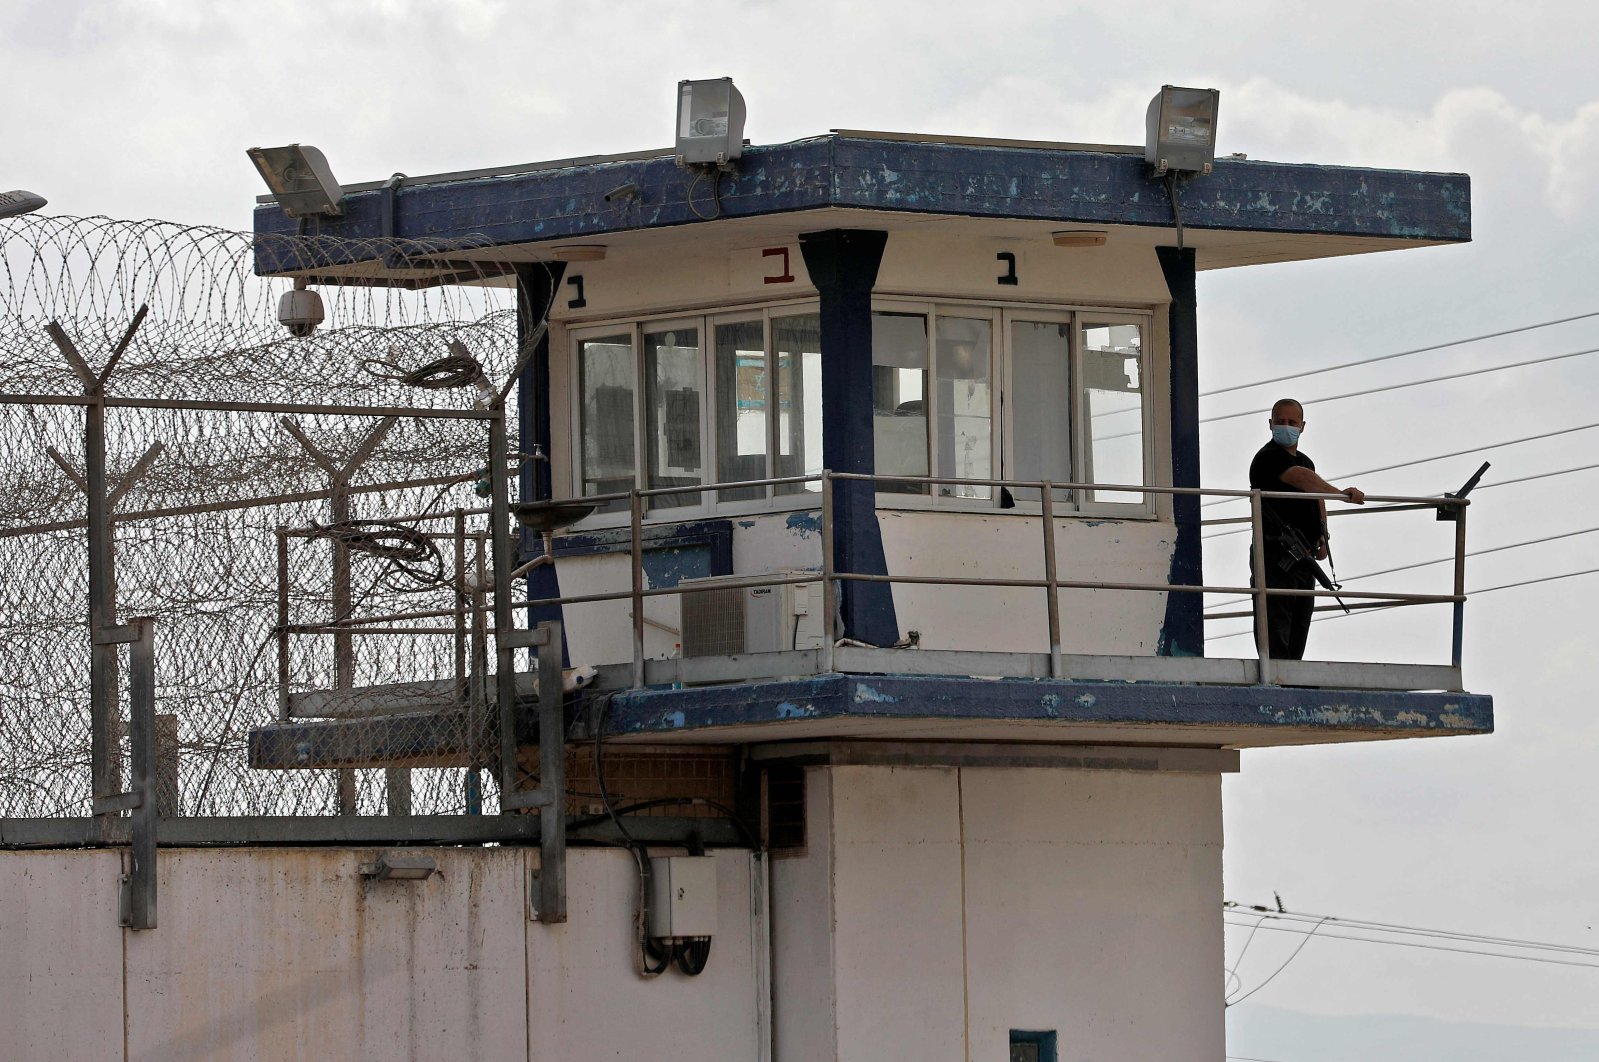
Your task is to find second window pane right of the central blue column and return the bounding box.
[932,317,993,497]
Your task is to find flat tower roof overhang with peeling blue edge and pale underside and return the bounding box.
[254,130,1471,286]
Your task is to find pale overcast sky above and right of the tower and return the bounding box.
[0,0,1599,1062]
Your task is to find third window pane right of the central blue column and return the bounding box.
[1006,321,1071,502]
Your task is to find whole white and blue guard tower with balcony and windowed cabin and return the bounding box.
[251,89,1492,1062]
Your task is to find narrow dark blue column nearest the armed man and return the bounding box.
[1154,246,1202,656]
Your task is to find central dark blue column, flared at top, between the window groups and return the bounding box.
[800,229,899,646]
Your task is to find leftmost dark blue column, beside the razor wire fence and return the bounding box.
[516,262,571,667]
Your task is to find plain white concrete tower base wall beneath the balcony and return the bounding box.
[774,766,1225,1062]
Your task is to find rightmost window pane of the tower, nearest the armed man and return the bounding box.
[1083,323,1145,505]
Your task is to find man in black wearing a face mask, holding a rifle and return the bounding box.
[1249,398,1366,661]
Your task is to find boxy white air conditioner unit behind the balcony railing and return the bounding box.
[680,573,823,657]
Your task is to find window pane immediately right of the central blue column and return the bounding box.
[871,312,927,494]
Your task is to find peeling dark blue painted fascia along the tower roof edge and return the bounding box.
[254,136,1471,272]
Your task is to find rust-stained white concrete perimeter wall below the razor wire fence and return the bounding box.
[0,848,764,1062]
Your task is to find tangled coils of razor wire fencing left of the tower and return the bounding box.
[0,214,543,817]
